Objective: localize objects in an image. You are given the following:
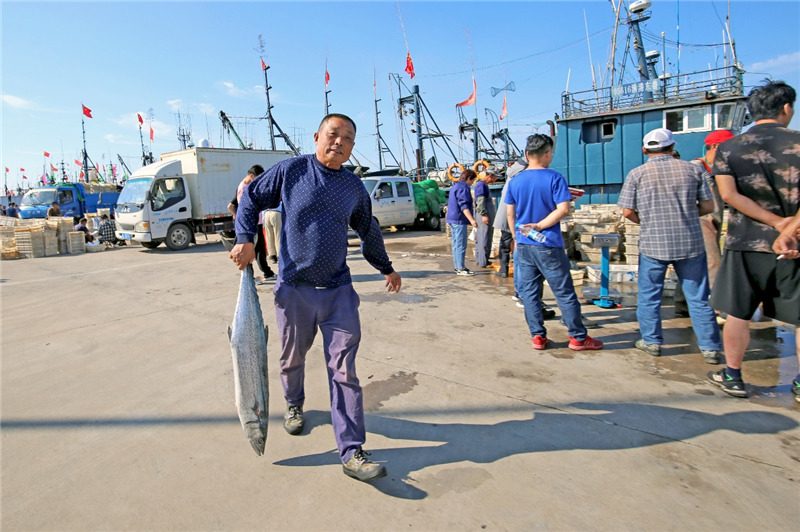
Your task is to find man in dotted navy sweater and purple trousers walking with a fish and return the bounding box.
[230,114,401,481]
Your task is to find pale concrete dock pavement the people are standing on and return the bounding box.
[0,232,800,531]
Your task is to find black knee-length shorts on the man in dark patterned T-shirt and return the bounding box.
[708,249,800,325]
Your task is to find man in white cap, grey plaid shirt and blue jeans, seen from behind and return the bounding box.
[619,128,722,364]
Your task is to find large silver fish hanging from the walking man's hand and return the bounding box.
[228,264,269,456]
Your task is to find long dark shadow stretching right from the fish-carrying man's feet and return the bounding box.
[275,403,798,500]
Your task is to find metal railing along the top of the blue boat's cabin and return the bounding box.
[561,66,744,118]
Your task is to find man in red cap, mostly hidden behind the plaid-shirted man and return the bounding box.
[674,129,733,318]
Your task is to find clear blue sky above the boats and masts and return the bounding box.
[0,0,800,191]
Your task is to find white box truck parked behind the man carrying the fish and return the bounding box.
[116,148,292,250]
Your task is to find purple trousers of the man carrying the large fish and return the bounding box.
[273,279,366,463]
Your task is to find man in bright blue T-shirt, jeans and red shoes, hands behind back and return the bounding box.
[505,134,603,351]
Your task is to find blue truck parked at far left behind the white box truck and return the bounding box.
[19,183,120,220]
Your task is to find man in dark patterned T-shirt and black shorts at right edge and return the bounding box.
[708,81,800,402]
